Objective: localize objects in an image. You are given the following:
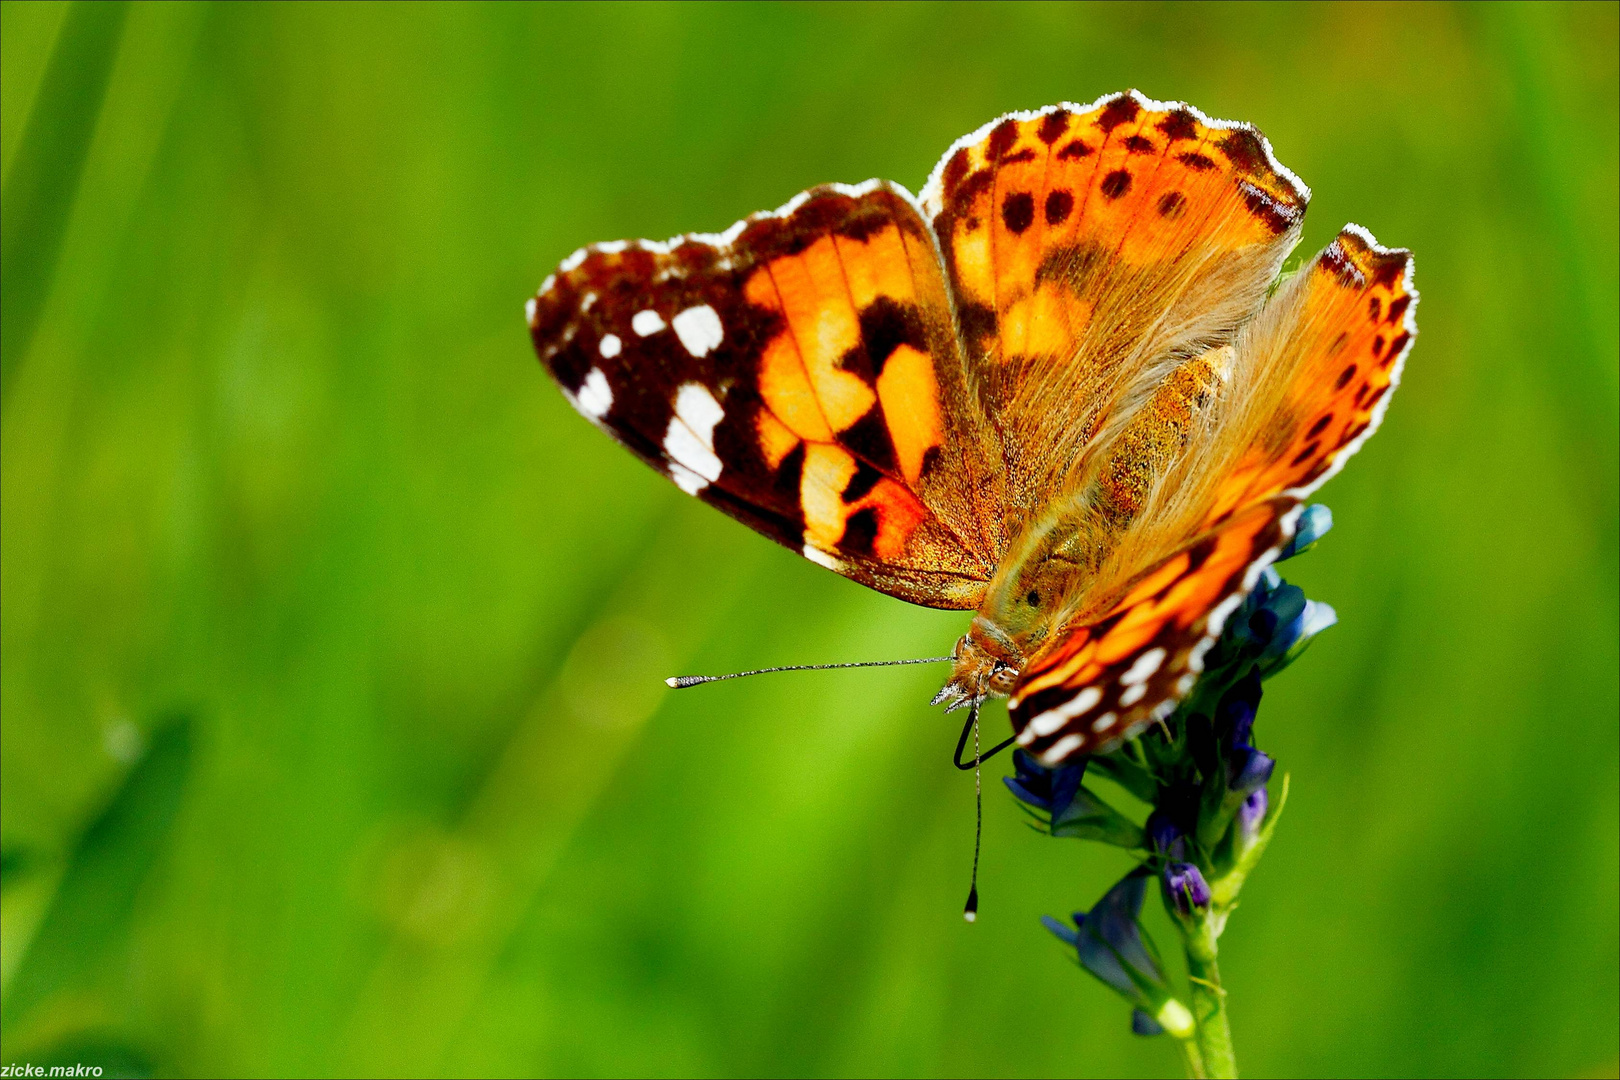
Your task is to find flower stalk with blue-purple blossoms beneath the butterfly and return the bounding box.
[1004,505,1335,1077]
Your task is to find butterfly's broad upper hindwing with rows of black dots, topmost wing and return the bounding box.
[922,91,1309,533]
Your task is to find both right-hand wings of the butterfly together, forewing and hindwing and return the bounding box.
[1009,225,1418,763]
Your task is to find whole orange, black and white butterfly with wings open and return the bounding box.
[527,91,1418,766]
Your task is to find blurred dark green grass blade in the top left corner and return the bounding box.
[0,0,128,402]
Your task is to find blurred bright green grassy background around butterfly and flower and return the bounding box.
[0,3,1620,1077]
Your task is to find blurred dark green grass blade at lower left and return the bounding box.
[0,714,191,1049]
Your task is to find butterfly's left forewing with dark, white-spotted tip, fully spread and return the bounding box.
[528,181,996,607]
